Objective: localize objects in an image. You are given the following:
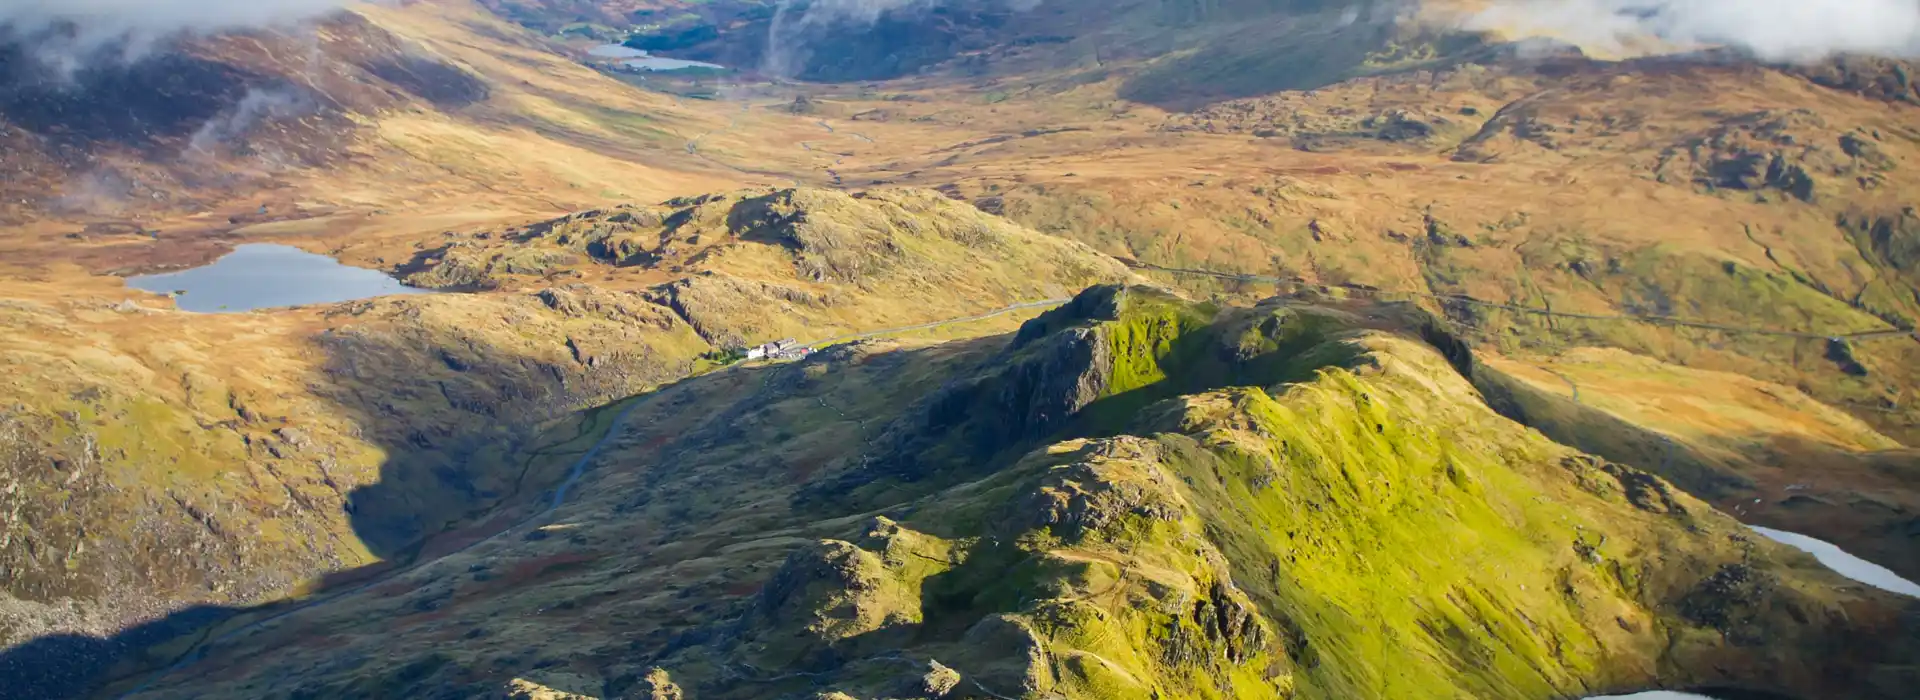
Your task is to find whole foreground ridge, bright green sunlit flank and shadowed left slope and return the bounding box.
[116,288,1916,698]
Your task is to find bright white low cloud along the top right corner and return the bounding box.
[1459,0,1920,61]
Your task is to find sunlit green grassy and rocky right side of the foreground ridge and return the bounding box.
[666,290,1910,698]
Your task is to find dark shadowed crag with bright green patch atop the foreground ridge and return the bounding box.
[804,286,1404,499]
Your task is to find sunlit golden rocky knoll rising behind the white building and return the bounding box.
[405,188,1123,290]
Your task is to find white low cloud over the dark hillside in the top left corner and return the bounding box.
[0,0,346,75]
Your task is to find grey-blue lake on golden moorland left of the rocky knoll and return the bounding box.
[127,244,430,313]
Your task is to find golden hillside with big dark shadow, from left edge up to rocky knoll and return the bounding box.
[0,190,1129,694]
